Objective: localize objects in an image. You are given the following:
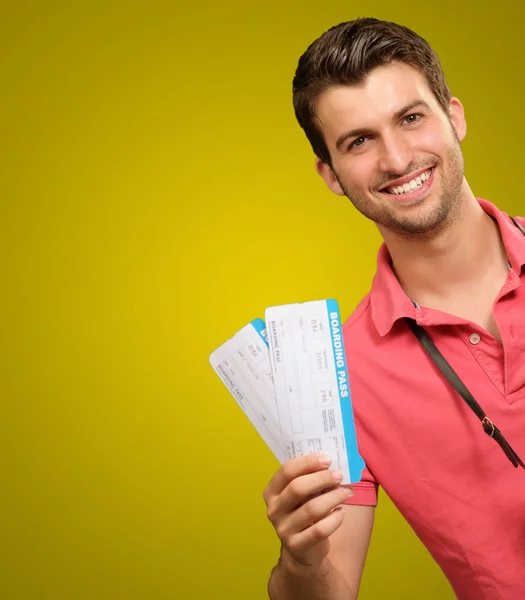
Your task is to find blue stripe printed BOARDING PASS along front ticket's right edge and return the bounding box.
[326,299,365,483]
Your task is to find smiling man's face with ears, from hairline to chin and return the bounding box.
[316,62,466,237]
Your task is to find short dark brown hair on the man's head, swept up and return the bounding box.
[293,18,452,166]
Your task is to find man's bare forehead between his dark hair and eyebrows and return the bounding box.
[316,62,439,146]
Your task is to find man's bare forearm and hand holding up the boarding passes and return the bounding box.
[264,455,374,600]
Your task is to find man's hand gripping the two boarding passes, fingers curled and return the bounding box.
[263,454,353,568]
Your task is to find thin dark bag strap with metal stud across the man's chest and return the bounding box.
[405,217,525,469]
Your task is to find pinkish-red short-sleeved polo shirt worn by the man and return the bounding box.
[344,200,525,600]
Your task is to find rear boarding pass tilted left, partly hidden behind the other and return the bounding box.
[210,319,287,464]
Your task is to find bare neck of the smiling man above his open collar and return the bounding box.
[381,182,508,304]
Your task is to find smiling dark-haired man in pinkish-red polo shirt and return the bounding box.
[264,19,525,600]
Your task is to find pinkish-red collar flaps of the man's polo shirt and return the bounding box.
[370,198,525,337]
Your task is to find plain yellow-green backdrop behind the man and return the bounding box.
[0,0,525,600]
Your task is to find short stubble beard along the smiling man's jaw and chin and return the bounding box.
[334,137,464,240]
